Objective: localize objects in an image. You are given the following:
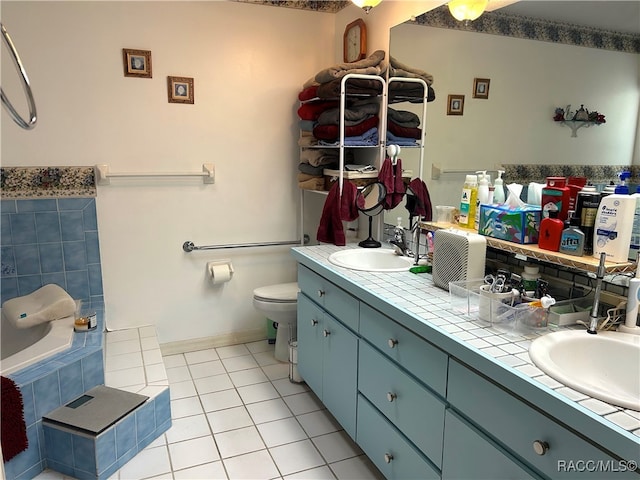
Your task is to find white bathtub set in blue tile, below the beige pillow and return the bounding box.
[0,314,75,376]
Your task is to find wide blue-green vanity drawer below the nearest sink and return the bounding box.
[447,359,638,479]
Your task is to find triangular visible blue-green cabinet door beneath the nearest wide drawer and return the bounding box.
[442,410,538,480]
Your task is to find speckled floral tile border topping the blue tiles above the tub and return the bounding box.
[0,167,96,200]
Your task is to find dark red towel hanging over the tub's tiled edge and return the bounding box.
[0,377,29,463]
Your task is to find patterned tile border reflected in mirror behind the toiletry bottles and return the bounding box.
[503,164,640,184]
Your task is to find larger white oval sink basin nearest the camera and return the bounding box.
[529,330,640,411]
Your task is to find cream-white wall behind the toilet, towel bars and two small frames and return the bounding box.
[1,1,335,343]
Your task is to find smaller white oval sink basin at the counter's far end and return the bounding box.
[329,248,414,272]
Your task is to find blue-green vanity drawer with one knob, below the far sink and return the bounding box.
[298,265,360,332]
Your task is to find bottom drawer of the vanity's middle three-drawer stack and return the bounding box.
[356,395,440,480]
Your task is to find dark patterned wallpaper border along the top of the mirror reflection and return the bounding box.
[407,5,640,53]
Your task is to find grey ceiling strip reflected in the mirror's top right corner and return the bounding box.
[496,0,640,35]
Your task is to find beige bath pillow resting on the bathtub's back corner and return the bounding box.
[2,283,76,328]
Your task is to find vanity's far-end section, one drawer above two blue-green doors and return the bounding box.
[298,267,359,439]
